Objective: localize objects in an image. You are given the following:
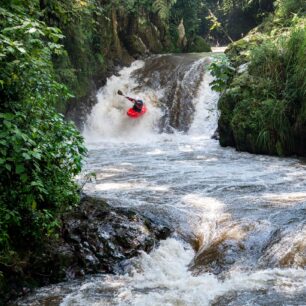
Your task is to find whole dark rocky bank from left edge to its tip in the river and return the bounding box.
[0,197,171,304]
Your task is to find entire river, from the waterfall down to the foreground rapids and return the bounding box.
[19,54,306,306]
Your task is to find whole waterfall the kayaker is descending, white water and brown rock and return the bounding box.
[84,55,218,141]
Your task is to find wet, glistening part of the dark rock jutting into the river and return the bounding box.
[63,198,171,277]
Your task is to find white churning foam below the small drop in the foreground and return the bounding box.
[61,238,306,306]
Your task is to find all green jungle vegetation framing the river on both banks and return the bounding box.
[0,0,306,302]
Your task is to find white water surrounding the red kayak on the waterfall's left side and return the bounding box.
[84,61,161,143]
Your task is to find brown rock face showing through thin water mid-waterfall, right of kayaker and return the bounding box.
[133,53,210,133]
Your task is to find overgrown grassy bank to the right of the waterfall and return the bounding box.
[213,0,306,156]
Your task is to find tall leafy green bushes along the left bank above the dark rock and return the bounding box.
[0,6,86,258]
